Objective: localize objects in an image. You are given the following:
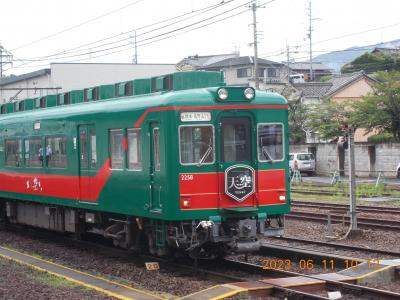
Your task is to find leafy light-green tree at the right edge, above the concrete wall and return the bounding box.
[352,71,400,141]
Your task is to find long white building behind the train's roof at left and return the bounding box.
[0,63,176,103]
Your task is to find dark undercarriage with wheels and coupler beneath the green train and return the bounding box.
[0,199,283,259]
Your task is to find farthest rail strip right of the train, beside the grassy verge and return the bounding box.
[292,201,400,214]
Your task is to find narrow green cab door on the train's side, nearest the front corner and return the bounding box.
[149,122,163,213]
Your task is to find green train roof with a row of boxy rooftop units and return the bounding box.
[0,71,287,123]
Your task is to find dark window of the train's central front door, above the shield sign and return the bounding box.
[221,117,251,162]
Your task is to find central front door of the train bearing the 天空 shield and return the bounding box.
[218,115,256,208]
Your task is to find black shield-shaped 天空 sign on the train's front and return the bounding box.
[225,165,254,202]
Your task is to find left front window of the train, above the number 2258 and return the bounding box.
[179,125,214,165]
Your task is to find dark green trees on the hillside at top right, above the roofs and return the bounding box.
[341,53,400,73]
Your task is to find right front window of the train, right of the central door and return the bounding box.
[257,124,283,161]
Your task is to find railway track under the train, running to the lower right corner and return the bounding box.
[4,225,400,299]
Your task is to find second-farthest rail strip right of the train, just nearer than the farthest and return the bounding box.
[285,211,400,231]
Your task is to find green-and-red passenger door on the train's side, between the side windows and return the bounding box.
[79,124,97,200]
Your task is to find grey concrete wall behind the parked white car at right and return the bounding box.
[290,143,400,177]
